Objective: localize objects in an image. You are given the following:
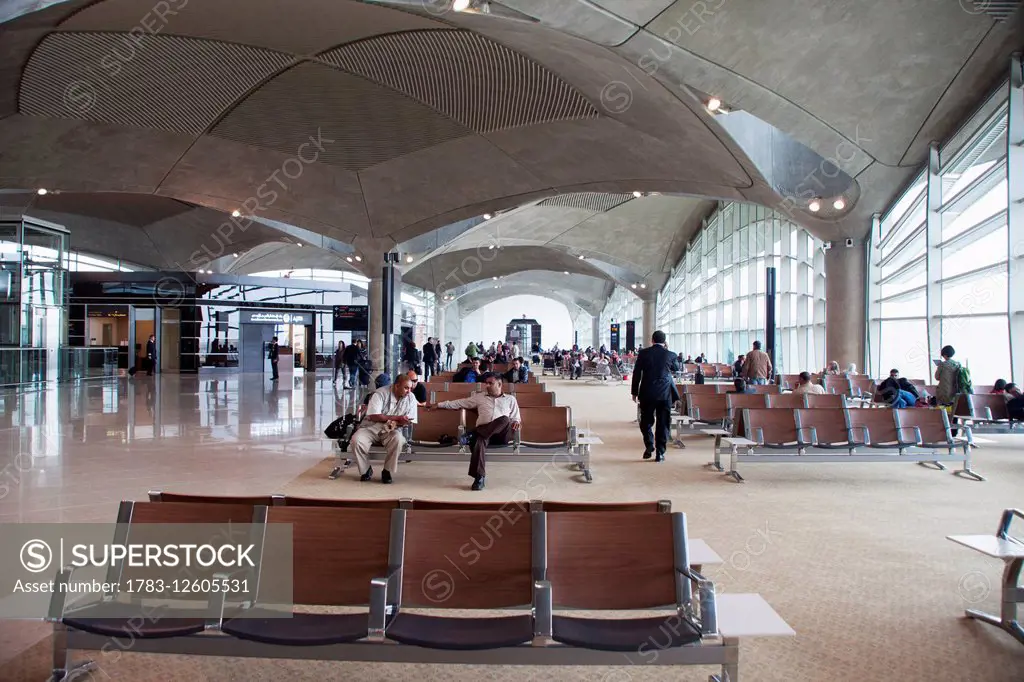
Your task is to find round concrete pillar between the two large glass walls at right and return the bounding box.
[823,242,867,372]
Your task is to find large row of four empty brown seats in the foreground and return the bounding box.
[53,502,718,663]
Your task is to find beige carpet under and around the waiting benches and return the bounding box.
[0,381,1024,682]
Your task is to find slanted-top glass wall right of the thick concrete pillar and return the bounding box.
[868,73,1024,384]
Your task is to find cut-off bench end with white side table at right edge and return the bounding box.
[946,509,1024,644]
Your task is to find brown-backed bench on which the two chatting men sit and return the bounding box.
[328,406,594,483]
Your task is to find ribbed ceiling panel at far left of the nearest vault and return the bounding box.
[19,33,291,135]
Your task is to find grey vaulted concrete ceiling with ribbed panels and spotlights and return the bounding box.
[0,0,1024,317]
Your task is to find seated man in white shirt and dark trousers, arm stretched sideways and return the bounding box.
[427,372,521,491]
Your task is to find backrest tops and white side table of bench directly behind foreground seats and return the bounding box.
[148,491,724,572]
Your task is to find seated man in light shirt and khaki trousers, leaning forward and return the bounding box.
[351,374,417,483]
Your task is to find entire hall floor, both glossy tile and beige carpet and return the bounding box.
[0,374,1024,682]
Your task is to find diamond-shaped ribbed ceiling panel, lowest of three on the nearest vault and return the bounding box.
[211,62,473,171]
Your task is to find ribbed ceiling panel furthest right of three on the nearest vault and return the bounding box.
[319,30,598,133]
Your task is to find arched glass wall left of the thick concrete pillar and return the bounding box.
[657,203,825,373]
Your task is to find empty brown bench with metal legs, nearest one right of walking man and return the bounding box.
[705,405,984,482]
